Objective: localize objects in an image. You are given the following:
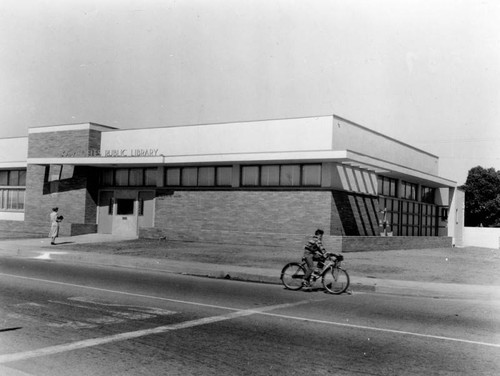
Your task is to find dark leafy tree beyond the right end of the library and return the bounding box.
[460,166,500,226]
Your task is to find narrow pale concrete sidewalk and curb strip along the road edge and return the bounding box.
[0,248,500,300]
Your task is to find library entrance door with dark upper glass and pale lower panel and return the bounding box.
[112,191,138,235]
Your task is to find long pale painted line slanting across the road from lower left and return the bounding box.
[0,300,310,364]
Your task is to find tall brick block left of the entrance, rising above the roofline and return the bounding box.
[25,130,100,236]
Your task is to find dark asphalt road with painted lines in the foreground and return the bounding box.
[0,258,500,376]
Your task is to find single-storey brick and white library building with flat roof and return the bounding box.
[0,115,464,251]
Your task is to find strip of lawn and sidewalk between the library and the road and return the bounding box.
[0,234,500,300]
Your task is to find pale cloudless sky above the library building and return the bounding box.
[0,0,500,185]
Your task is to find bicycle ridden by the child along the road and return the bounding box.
[280,253,350,295]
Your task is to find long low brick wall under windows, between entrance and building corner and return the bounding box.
[155,190,331,234]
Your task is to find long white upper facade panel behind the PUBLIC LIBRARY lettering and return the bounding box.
[101,116,332,156]
